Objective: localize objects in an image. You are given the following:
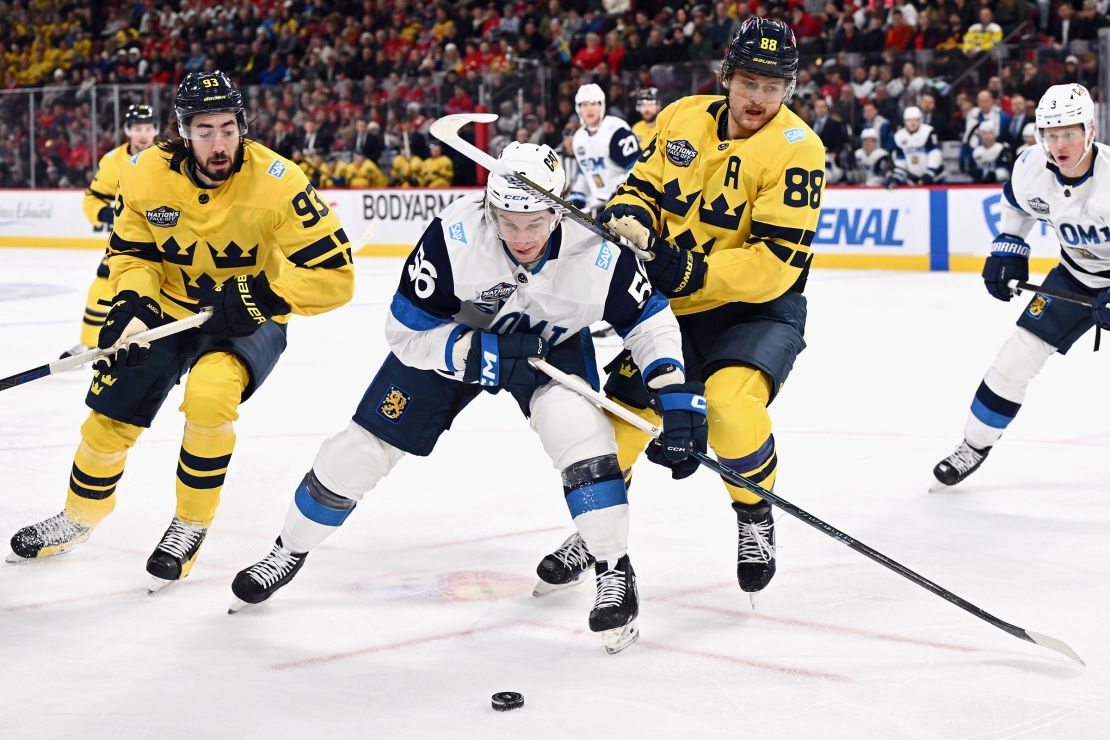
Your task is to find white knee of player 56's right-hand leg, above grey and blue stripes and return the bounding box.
[528,383,617,470]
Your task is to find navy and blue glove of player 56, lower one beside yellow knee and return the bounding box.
[647,383,709,480]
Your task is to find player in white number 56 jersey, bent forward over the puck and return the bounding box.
[231,142,708,652]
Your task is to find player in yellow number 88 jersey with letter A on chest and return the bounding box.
[537,18,825,599]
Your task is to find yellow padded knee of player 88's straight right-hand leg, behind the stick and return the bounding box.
[705,365,778,504]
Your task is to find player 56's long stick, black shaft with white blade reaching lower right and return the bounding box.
[529,359,1087,666]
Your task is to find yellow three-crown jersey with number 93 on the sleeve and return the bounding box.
[108,141,354,321]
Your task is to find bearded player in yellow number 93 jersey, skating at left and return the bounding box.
[9,72,354,591]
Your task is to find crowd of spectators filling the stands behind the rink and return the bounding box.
[0,0,1110,187]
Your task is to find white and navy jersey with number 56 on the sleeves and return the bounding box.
[385,193,682,379]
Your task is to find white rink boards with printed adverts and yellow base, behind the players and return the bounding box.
[0,187,1059,271]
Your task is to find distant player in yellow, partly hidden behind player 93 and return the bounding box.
[62,105,158,357]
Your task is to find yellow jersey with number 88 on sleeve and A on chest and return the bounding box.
[609,95,825,315]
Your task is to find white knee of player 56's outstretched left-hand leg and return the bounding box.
[312,422,405,501]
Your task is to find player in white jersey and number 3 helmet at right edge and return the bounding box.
[931,84,1110,490]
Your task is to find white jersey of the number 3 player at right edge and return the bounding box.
[1000,143,1110,290]
